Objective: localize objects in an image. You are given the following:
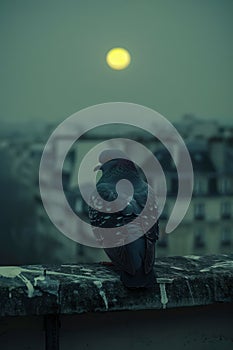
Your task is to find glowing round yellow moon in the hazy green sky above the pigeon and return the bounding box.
[106,47,131,70]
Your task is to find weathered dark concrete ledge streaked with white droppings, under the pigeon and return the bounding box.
[0,254,233,316]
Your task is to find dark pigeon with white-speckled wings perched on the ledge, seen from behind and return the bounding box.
[89,149,159,289]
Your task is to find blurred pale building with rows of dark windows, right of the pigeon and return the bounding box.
[155,130,233,256]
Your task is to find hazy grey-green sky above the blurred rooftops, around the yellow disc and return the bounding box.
[0,0,233,122]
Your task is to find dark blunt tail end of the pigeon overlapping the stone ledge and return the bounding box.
[121,268,155,289]
